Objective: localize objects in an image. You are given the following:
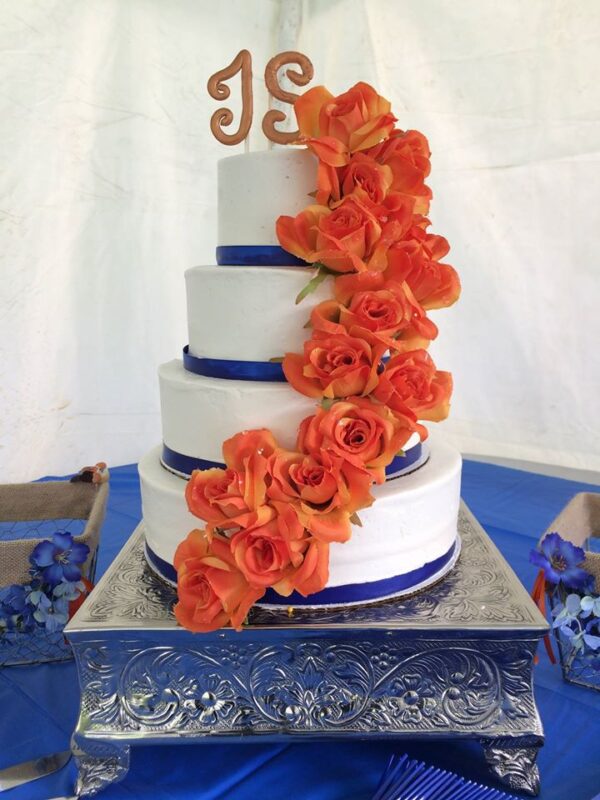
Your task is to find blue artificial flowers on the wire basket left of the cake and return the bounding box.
[0,531,90,637]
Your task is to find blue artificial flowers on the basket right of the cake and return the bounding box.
[529,533,600,685]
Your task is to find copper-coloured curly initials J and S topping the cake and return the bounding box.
[208,50,314,145]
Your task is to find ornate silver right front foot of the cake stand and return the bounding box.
[481,736,544,797]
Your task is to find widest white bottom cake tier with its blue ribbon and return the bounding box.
[139,441,461,607]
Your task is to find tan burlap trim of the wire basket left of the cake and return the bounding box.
[0,481,108,586]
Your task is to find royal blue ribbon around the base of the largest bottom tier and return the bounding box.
[146,542,456,606]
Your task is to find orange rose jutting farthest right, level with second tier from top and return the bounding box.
[385,225,460,309]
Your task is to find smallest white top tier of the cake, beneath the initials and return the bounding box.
[217,147,317,253]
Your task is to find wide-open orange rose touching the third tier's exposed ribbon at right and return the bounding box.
[298,397,418,483]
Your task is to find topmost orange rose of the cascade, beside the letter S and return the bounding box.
[294,83,396,166]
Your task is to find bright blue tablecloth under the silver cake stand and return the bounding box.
[0,461,600,800]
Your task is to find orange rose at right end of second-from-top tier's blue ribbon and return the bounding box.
[283,334,385,398]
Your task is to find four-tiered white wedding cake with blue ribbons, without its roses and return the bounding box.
[139,136,461,605]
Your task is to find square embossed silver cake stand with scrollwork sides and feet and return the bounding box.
[67,505,548,796]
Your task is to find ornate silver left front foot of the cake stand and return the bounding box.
[71,734,129,797]
